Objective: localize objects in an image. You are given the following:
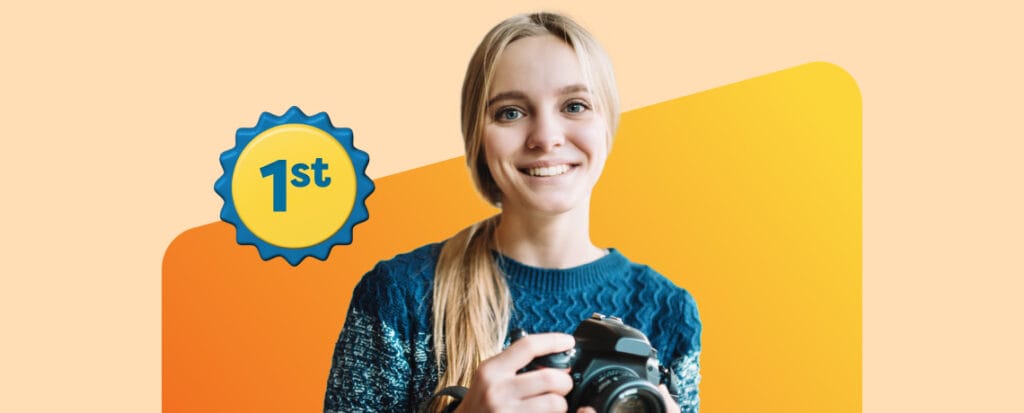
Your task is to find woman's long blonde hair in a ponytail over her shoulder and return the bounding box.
[432,12,620,409]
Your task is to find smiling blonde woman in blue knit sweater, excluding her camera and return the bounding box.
[325,13,700,413]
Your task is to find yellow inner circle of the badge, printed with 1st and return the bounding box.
[231,123,356,248]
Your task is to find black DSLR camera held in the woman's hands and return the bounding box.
[512,313,679,413]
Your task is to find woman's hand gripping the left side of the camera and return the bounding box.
[456,333,575,413]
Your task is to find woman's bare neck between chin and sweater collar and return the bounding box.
[495,204,607,269]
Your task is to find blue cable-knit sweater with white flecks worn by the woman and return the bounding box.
[324,244,700,413]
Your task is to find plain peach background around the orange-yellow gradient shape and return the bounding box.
[0,1,1024,412]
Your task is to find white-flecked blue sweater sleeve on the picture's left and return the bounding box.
[324,264,412,413]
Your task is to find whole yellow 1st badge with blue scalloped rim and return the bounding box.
[214,107,374,265]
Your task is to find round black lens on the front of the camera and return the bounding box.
[581,368,665,413]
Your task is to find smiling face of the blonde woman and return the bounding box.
[483,35,608,213]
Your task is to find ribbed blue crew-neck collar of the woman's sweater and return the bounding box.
[494,248,629,292]
